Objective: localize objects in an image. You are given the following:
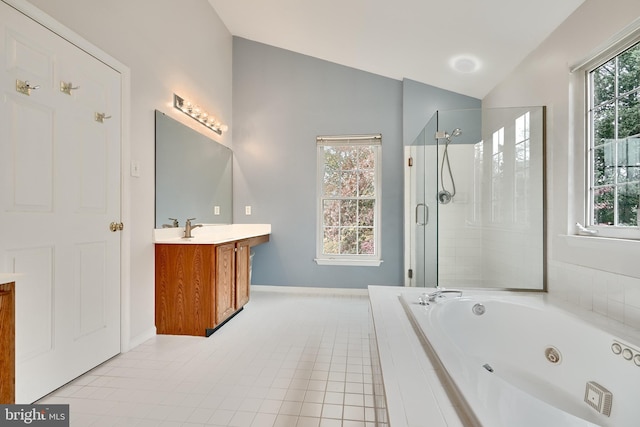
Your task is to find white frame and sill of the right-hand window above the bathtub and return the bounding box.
[584,29,640,240]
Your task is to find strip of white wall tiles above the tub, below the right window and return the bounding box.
[548,262,640,329]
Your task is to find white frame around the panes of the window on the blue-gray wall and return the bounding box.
[314,134,382,266]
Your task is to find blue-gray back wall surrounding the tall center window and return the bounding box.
[233,37,479,288]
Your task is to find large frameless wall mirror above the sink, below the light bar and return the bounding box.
[155,110,233,228]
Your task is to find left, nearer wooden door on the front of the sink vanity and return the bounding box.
[215,242,236,326]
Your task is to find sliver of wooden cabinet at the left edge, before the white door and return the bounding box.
[0,282,16,404]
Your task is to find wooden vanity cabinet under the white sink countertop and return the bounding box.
[155,235,269,336]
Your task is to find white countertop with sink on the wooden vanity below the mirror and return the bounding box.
[153,224,271,245]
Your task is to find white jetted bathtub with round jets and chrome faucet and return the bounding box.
[401,288,640,427]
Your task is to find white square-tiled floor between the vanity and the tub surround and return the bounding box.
[38,291,375,427]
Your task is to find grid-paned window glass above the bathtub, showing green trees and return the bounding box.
[588,43,640,232]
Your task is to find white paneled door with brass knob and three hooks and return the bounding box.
[0,2,121,403]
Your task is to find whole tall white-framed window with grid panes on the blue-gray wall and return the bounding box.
[316,135,382,265]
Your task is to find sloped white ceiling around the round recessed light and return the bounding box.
[209,0,584,98]
